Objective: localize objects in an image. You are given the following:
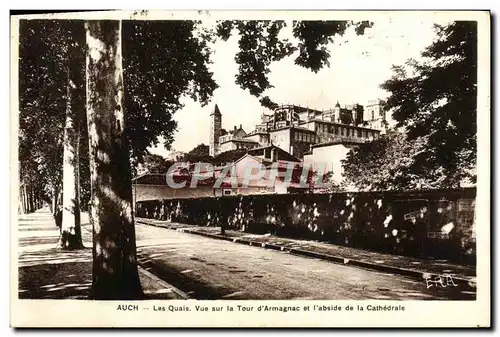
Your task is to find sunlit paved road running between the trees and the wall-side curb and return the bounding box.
[136,225,464,300]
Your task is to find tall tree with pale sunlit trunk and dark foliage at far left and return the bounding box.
[19,20,85,248]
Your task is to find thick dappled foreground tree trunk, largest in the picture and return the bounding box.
[85,21,144,300]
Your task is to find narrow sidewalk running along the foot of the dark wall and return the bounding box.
[135,218,476,290]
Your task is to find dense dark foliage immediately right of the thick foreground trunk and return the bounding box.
[122,20,217,162]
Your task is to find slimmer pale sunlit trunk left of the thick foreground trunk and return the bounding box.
[58,66,84,249]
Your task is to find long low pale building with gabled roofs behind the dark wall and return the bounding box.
[133,145,316,202]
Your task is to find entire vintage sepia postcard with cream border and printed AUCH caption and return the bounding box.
[10,10,491,328]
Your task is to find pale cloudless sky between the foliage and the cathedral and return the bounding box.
[150,16,450,156]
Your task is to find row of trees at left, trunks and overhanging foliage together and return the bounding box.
[19,20,376,299]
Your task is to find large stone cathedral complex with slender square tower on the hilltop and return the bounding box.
[210,101,387,159]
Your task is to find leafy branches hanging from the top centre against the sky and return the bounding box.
[215,20,373,109]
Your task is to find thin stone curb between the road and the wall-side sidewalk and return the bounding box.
[136,220,476,291]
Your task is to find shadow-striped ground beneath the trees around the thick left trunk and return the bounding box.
[17,209,188,299]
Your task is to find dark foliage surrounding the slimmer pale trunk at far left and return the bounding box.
[19,20,88,207]
